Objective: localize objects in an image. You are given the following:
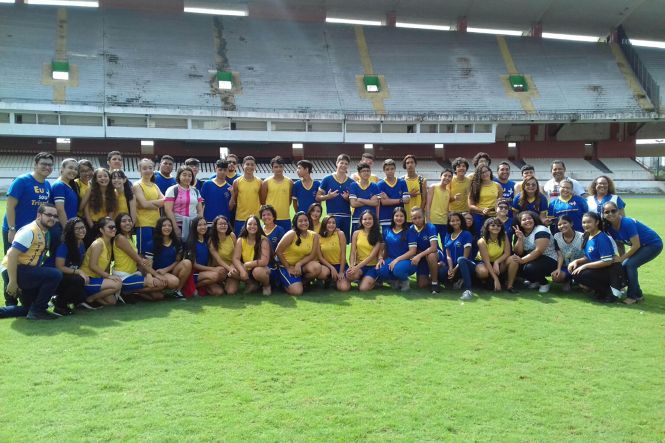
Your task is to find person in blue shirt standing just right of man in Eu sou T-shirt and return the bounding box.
[48,158,79,265]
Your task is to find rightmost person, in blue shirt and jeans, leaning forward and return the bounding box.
[603,202,663,304]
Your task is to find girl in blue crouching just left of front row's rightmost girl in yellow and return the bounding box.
[443,212,476,300]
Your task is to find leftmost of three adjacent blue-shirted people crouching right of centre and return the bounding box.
[376,206,412,291]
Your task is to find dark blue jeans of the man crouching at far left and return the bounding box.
[0,265,62,318]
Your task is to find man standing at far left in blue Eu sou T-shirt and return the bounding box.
[2,152,54,254]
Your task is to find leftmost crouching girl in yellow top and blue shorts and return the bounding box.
[81,217,122,308]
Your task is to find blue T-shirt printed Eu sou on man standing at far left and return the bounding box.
[2,174,51,232]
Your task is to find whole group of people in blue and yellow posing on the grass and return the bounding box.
[0,151,663,319]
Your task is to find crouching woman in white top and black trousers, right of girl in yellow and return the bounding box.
[506,211,557,294]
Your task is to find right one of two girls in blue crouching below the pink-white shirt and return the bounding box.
[188,216,226,295]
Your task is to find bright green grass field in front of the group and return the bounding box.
[0,199,665,442]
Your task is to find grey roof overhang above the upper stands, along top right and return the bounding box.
[195,0,665,41]
